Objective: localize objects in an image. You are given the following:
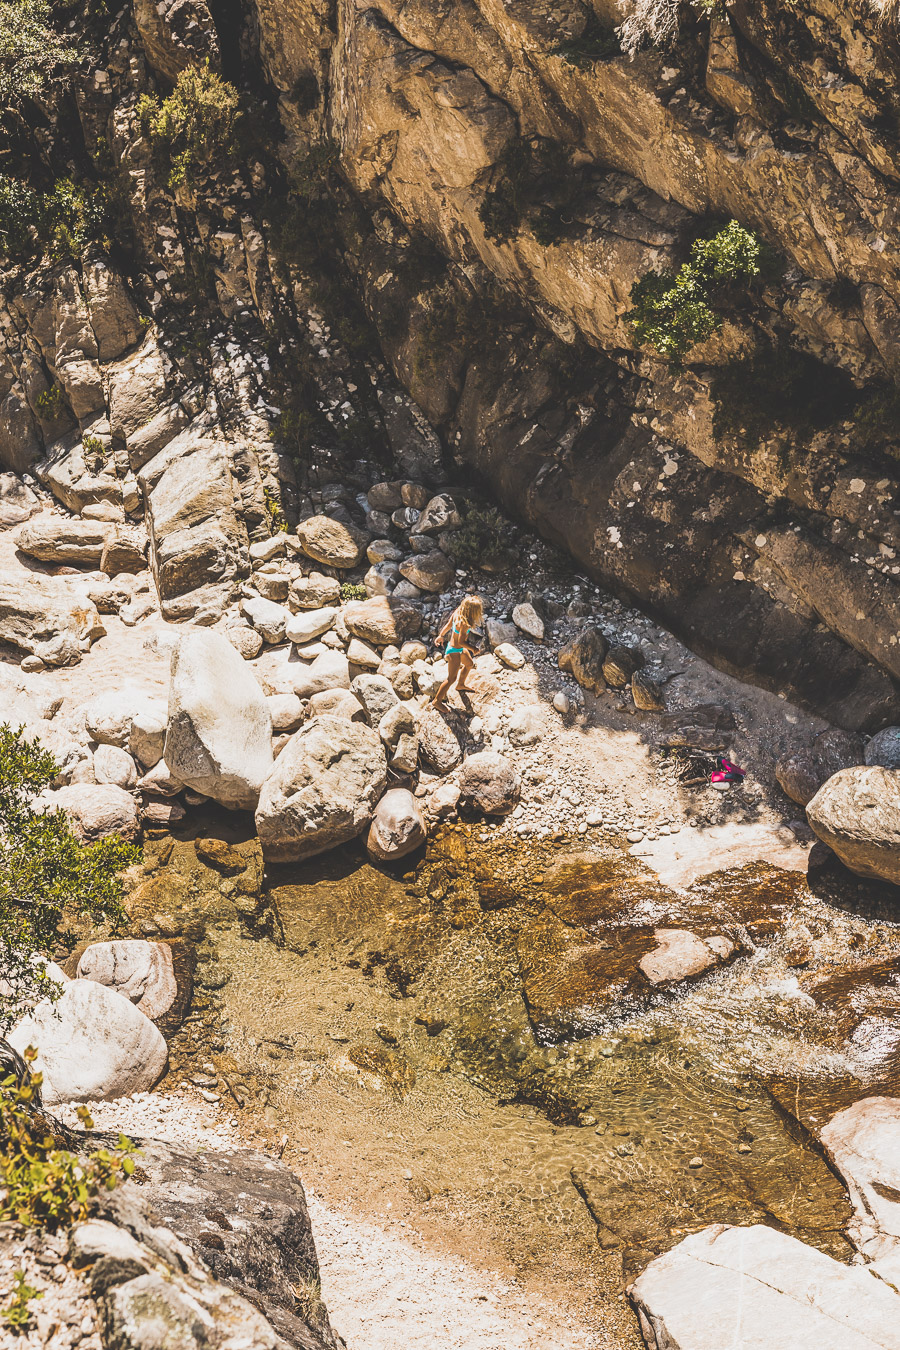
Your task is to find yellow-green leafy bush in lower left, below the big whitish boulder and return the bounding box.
[0,1048,135,1231]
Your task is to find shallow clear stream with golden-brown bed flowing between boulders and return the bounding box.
[121,813,900,1347]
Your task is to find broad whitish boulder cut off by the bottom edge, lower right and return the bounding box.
[629,1223,900,1350]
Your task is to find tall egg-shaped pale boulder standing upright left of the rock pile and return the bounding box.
[165,629,273,810]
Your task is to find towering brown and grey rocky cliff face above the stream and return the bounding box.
[0,0,900,729]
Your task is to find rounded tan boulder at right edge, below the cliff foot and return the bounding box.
[807,767,900,886]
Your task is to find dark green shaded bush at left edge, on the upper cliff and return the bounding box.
[0,174,107,262]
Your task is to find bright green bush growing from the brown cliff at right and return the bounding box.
[626,220,762,362]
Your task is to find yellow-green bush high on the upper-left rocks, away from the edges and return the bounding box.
[138,62,240,189]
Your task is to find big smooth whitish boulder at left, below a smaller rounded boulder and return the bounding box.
[8,980,166,1106]
